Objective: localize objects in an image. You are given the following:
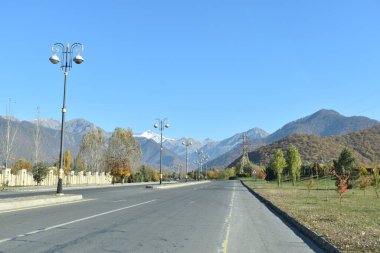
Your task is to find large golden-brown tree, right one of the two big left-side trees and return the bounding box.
[106,128,141,178]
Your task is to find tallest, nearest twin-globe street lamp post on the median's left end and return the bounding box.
[49,43,84,194]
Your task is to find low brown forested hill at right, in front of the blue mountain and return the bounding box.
[230,125,380,166]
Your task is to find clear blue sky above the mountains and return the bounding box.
[0,0,380,140]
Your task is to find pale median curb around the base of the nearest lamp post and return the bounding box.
[0,194,83,213]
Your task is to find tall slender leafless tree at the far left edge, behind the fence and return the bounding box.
[0,98,19,168]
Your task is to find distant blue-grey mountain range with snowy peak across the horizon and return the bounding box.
[0,109,379,172]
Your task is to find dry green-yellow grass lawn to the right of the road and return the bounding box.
[244,179,380,252]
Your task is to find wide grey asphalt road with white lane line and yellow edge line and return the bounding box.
[0,181,323,253]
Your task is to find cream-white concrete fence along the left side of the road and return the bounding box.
[0,168,112,186]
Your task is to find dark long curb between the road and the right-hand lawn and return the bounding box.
[240,180,341,253]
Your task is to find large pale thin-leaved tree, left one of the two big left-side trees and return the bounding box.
[78,128,105,173]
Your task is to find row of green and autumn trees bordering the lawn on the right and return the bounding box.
[235,145,380,198]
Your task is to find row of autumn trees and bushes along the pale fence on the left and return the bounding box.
[4,128,142,184]
